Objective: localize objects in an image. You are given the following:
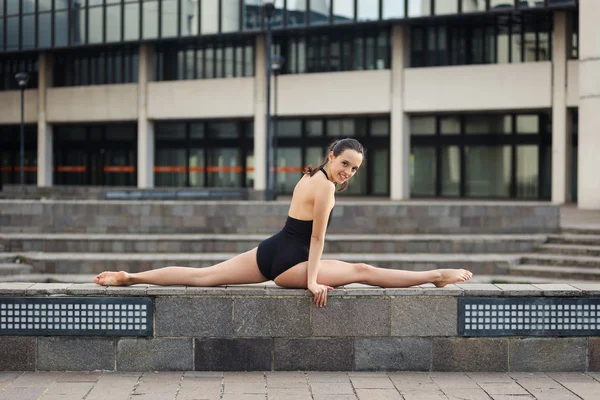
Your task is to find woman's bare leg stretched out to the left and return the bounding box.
[94,248,267,286]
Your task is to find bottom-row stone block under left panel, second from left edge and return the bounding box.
[37,337,115,371]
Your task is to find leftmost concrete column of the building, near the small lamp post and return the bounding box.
[37,53,53,187]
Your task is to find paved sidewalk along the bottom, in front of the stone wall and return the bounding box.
[0,372,600,400]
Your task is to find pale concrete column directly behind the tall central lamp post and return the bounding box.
[254,35,267,191]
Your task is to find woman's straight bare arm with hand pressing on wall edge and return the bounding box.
[307,182,335,306]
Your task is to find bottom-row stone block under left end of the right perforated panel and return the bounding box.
[431,338,508,372]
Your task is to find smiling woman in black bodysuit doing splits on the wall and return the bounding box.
[94,138,472,307]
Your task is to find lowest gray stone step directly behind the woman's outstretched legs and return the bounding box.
[5,252,519,274]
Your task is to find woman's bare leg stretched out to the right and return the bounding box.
[275,260,473,288]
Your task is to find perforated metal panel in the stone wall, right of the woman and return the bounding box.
[458,297,600,336]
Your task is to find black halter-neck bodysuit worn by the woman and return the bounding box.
[256,168,331,280]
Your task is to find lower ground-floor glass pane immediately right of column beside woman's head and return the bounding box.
[410,146,436,196]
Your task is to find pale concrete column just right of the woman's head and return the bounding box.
[390,25,410,200]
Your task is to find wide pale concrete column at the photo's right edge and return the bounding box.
[577,0,600,210]
